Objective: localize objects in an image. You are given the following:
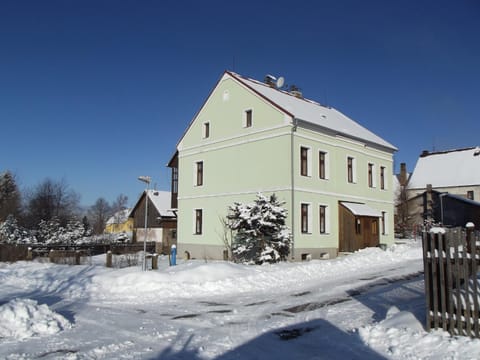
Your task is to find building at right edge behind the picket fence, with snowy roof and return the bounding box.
[403,147,480,229]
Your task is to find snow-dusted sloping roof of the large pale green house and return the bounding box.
[228,72,397,151]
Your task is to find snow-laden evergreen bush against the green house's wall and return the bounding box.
[227,194,291,264]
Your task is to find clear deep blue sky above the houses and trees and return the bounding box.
[0,0,480,206]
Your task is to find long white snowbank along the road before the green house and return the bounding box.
[86,243,422,303]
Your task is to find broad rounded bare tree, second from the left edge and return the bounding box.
[25,178,80,229]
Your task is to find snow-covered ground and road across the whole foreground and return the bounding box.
[0,241,480,360]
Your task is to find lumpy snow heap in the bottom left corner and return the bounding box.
[0,299,71,340]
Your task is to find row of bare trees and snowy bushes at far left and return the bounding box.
[0,171,128,243]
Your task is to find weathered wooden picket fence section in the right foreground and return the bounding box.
[423,228,480,338]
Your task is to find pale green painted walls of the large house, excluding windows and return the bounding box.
[178,76,393,259]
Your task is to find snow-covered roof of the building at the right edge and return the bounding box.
[408,147,480,189]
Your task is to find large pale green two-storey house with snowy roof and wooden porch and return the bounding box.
[168,71,397,260]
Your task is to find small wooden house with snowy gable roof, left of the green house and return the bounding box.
[130,190,177,253]
